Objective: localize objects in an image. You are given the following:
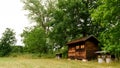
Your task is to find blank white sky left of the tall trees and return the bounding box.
[0,0,32,45]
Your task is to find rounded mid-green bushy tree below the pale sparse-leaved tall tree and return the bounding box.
[21,27,47,54]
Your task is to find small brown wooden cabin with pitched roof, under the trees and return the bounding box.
[67,35,99,60]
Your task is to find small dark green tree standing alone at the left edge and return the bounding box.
[0,28,16,56]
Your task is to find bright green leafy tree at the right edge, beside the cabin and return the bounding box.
[92,0,120,60]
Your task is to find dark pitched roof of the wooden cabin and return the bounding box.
[67,35,99,45]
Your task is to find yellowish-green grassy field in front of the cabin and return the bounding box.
[0,57,120,68]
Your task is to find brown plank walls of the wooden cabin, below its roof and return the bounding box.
[68,41,98,59]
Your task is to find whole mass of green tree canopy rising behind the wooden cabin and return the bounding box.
[22,0,120,57]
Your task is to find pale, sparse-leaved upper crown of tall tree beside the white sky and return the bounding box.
[21,0,56,33]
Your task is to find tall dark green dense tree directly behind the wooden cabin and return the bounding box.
[50,0,101,46]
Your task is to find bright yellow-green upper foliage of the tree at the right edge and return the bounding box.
[92,0,120,29]
